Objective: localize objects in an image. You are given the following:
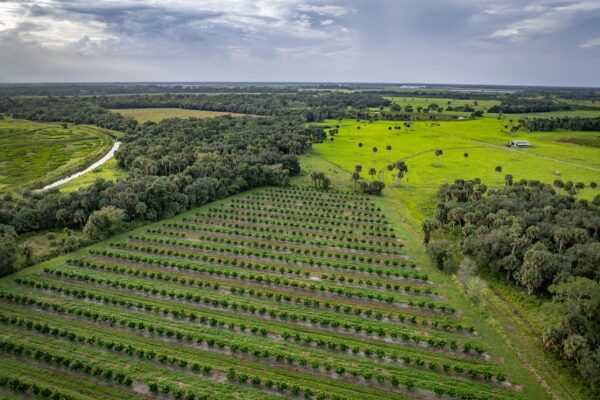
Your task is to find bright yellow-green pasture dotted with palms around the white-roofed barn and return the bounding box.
[314,118,600,219]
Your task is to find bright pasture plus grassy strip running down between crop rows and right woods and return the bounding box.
[293,119,600,400]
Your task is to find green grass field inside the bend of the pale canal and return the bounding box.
[0,119,117,192]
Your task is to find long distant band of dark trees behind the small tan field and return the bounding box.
[0,93,391,123]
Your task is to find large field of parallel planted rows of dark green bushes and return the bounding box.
[0,188,519,400]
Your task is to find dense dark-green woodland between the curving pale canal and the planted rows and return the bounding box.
[0,117,324,238]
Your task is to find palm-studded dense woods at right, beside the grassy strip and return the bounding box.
[423,179,600,390]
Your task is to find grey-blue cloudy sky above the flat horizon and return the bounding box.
[0,0,600,86]
